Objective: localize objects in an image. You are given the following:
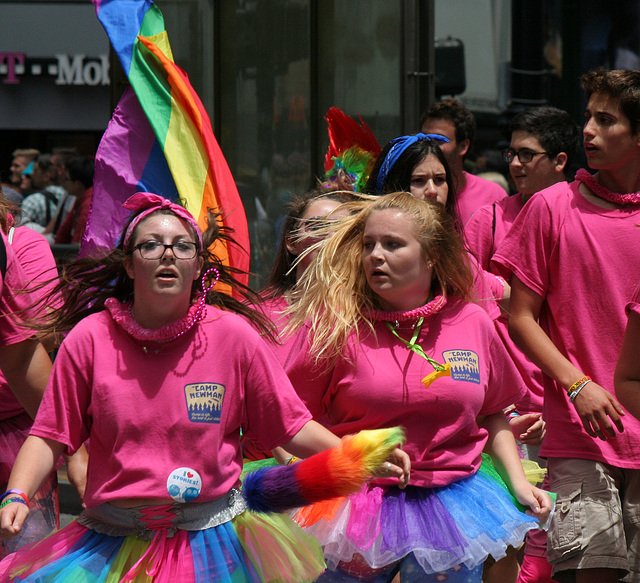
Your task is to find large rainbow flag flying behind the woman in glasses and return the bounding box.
[86,0,250,283]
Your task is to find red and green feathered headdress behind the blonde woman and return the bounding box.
[323,107,382,192]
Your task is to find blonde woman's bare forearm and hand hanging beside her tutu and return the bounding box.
[478,412,551,524]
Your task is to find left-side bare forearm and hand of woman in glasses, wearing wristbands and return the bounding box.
[0,435,64,539]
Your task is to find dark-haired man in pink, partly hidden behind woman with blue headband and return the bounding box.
[420,97,507,227]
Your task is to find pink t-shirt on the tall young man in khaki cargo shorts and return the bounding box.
[493,181,640,469]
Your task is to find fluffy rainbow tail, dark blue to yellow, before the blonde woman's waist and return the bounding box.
[242,427,404,512]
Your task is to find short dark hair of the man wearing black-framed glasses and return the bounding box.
[509,105,582,177]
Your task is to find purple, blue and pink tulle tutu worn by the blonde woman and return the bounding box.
[294,459,538,573]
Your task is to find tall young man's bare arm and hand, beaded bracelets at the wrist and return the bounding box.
[509,275,624,441]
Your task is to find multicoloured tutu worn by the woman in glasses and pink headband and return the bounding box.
[0,497,324,583]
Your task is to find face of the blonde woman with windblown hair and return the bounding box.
[362,209,433,312]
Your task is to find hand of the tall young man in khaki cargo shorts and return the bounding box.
[573,381,624,441]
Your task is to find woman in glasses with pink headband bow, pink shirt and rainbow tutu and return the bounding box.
[0,193,408,583]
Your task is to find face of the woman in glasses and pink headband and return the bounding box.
[125,214,202,311]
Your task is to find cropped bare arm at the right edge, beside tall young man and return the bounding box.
[613,312,640,419]
